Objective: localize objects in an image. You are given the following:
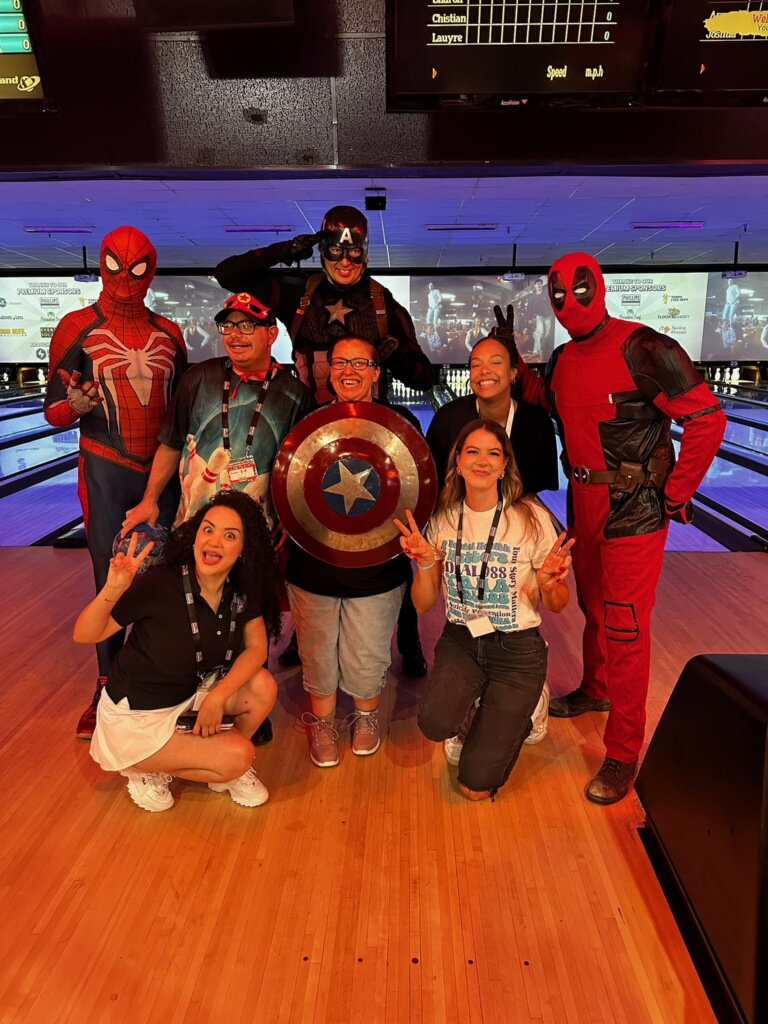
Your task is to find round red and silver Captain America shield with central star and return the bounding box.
[271,401,437,568]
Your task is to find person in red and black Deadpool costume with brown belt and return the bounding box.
[547,253,725,804]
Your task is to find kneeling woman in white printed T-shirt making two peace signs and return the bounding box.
[395,420,573,800]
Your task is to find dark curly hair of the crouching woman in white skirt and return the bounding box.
[158,490,281,640]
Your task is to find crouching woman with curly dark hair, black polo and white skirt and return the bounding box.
[75,492,280,811]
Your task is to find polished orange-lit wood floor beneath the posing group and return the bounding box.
[0,548,768,1024]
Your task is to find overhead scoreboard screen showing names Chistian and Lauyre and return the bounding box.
[387,0,649,110]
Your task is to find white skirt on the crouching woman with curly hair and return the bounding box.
[91,687,195,771]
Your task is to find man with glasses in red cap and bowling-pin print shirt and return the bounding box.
[123,292,310,531]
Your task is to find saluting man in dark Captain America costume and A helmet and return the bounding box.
[213,206,434,678]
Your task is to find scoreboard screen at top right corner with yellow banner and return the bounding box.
[653,0,768,105]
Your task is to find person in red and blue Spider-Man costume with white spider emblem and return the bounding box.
[44,226,186,676]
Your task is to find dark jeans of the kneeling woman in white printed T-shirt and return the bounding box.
[418,623,547,793]
